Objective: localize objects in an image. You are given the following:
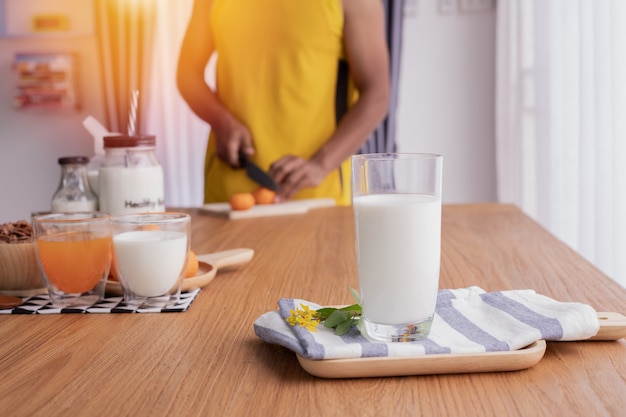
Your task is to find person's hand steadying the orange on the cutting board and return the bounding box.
[269,155,326,201]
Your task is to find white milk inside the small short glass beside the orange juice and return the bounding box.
[113,230,187,297]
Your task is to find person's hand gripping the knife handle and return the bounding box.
[212,116,254,168]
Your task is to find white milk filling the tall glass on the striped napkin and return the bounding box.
[353,194,441,325]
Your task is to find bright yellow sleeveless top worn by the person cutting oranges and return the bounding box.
[204,0,350,205]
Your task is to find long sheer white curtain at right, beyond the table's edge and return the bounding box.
[496,0,626,286]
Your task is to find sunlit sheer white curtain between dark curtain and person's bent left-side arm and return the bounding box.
[144,0,210,207]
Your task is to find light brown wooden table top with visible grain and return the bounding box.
[0,204,626,416]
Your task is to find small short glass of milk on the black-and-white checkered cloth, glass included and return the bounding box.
[111,212,191,308]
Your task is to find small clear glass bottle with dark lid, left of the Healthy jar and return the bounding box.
[52,156,98,212]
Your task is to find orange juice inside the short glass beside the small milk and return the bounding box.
[37,232,111,293]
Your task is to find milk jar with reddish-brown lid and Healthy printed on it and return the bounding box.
[98,135,165,216]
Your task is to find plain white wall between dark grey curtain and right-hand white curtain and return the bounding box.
[396,0,496,203]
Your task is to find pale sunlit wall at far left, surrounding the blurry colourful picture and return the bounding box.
[0,0,105,223]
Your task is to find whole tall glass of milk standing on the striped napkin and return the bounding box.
[352,153,443,342]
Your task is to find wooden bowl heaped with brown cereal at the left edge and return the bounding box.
[0,220,46,296]
